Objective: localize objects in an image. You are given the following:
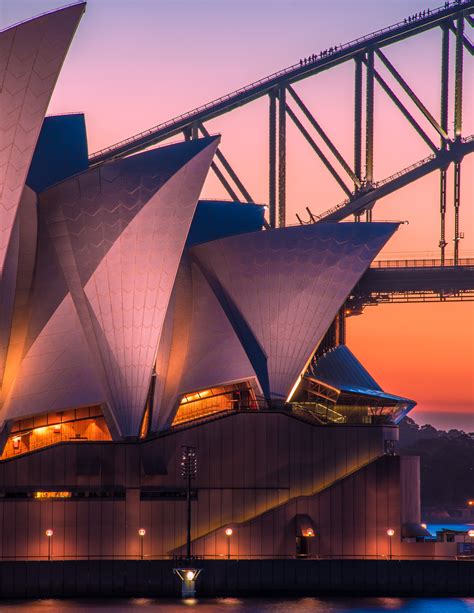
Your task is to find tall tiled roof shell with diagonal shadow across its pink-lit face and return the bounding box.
[40,139,217,436]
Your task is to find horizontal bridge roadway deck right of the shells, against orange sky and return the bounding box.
[350,258,474,310]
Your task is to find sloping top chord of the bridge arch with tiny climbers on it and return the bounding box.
[89,0,474,166]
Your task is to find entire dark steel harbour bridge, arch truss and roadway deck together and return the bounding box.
[90,0,474,314]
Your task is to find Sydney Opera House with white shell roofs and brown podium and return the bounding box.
[0,4,435,559]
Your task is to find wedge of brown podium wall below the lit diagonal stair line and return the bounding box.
[180,455,428,558]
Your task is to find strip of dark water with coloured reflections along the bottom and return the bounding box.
[0,598,474,613]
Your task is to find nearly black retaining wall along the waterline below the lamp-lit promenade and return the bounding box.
[0,560,474,598]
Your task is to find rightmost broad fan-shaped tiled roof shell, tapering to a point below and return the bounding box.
[192,223,398,401]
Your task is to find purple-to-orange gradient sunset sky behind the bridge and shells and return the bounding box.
[0,0,474,431]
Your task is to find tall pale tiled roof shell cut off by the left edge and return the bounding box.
[0,3,85,273]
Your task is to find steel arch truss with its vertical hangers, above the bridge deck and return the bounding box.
[90,0,474,270]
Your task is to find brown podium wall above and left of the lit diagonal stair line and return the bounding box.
[0,411,398,559]
